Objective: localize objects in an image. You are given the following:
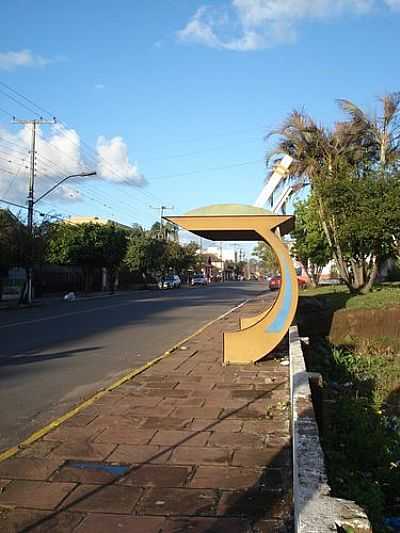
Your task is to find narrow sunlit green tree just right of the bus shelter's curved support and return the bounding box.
[291,194,332,287]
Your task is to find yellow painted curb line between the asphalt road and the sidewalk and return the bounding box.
[0,298,250,463]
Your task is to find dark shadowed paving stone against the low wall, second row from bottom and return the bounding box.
[217,489,291,521]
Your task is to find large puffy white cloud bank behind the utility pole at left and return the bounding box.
[0,124,145,203]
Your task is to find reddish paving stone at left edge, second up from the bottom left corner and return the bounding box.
[0,480,75,509]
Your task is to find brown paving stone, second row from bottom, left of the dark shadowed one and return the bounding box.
[136,488,218,516]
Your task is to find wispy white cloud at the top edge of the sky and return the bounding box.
[177,0,378,51]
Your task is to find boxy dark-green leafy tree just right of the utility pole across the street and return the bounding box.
[48,223,127,290]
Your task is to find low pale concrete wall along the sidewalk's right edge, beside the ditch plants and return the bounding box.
[289,326,372,533]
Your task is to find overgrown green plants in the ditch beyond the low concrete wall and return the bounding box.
[306,339,400,532]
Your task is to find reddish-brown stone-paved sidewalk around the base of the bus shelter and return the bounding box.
[0,299,291,533]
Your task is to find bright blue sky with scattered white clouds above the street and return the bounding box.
[0,0,400,247]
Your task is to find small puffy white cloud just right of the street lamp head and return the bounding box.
[97,137,145,186]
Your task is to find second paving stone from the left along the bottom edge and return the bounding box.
[75,514,165,533]
